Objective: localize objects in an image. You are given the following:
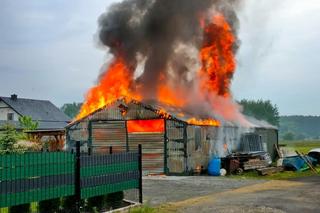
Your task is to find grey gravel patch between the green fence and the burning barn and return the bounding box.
[143,176,265,206]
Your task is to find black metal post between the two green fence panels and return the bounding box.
[74,141,81,213]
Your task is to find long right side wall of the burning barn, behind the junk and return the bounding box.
[187,125,277,171]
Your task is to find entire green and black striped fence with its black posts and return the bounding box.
[0,143,142,209]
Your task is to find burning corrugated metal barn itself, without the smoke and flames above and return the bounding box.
[67,100,278,174]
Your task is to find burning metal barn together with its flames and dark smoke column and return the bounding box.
[67,0,277,174]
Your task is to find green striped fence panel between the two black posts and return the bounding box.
[80,149,141,199]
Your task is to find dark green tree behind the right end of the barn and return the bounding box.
[239,99,279,126]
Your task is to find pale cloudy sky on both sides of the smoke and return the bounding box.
[0,0,320,115]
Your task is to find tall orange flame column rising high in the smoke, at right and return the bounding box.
[199,14,236,97]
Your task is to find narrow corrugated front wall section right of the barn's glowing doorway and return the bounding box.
[166,120,187,173]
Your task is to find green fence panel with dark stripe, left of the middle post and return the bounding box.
[0,152,75,207]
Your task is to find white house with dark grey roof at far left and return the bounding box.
[0,94,71,131]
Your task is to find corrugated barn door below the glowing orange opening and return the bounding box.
[128,132,164,174]
